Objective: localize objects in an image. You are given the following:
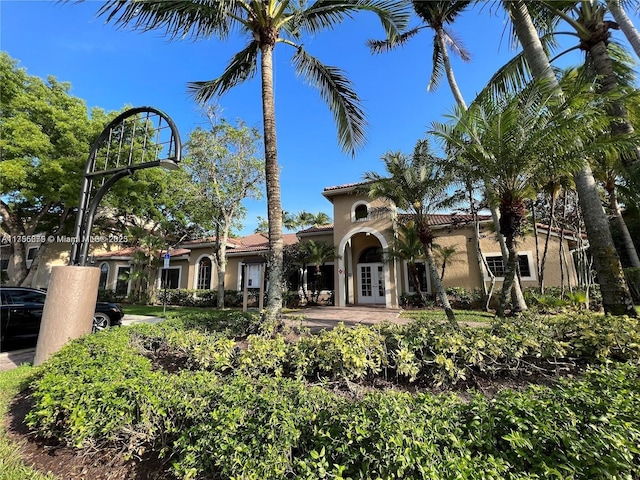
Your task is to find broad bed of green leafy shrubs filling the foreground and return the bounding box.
[5,312,640,479]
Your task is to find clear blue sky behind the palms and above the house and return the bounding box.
[0,0,639,234]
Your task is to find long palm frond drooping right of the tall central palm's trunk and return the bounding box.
[292,47,366,155]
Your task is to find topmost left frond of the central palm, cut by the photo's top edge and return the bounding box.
[90,0,240,40]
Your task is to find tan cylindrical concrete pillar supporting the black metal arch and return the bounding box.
[33,265,100,366]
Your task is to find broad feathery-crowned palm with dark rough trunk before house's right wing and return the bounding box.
[434,81,606,316]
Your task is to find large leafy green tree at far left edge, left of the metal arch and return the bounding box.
[0,52,107,285]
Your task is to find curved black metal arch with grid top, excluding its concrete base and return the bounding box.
[69,107,182,266]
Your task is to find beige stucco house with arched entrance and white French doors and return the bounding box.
[7,183,576,308]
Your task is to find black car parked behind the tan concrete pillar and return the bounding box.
[0,287,124,351]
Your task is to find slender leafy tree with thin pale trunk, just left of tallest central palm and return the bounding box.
[183,108,264,308]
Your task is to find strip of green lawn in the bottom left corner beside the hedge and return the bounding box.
[0,365,56,480]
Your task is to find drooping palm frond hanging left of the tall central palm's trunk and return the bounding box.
[187,40,260,104]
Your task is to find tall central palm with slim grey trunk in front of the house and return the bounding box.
[89,0,408,320]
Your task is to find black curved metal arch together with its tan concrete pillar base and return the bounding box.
[34,107,181,365]
